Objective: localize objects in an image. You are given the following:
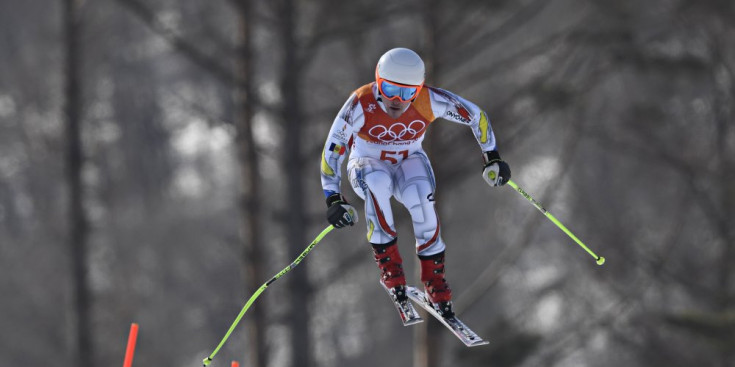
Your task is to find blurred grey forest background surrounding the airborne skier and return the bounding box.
[0,0,735,367]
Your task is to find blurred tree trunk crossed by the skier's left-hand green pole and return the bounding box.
[235,0,268,366]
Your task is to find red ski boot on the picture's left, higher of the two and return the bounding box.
[371,239,408,303]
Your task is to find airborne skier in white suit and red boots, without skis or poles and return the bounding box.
[321,48,510,317]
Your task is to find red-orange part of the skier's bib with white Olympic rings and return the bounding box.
[355,82,435,145]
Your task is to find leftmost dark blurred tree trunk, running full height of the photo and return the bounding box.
[64,0,93,367]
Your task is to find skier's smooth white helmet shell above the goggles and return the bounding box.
[375,48,425,85]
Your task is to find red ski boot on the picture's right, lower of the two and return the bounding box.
[419,251,454,318]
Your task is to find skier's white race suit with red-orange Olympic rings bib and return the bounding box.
[321,82,496,256]
